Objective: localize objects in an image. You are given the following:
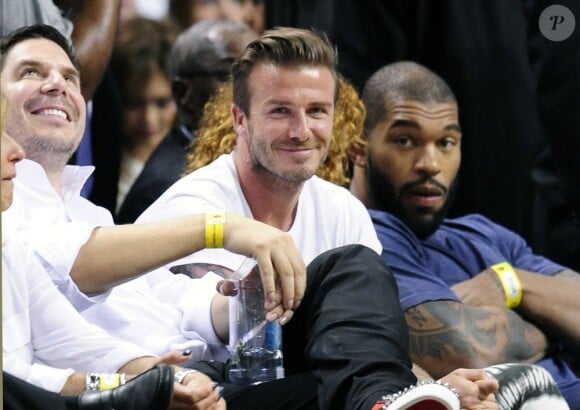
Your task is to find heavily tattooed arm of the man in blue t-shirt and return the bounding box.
[405,301,548,378]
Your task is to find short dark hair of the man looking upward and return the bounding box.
[0,24,81,73]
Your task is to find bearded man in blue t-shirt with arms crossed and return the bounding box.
[351,62,580,409]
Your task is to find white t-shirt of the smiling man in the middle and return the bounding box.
[137,154,382,269]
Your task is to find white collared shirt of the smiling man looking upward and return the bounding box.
[3,160,223,360]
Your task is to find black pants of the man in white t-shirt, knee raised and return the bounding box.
[196,245,416,410]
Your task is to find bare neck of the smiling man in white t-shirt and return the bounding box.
[234,152,304,231]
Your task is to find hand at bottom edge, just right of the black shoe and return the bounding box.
[169,372,226,410]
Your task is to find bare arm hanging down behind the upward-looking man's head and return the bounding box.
[55,0,121,101]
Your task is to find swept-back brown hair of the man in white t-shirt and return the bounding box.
[232,27,338,116]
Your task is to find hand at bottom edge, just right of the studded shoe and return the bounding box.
[440,369,499,410]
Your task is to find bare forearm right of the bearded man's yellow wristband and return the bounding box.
[517,270,580,350]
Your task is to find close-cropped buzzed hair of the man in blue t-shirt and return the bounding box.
[362,61,457,136]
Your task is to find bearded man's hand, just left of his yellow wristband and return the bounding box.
[451,268,506,308]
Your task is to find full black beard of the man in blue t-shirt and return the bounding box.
[367,156,458,239]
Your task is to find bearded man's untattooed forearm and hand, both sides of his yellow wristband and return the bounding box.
[452,268,580,351]
